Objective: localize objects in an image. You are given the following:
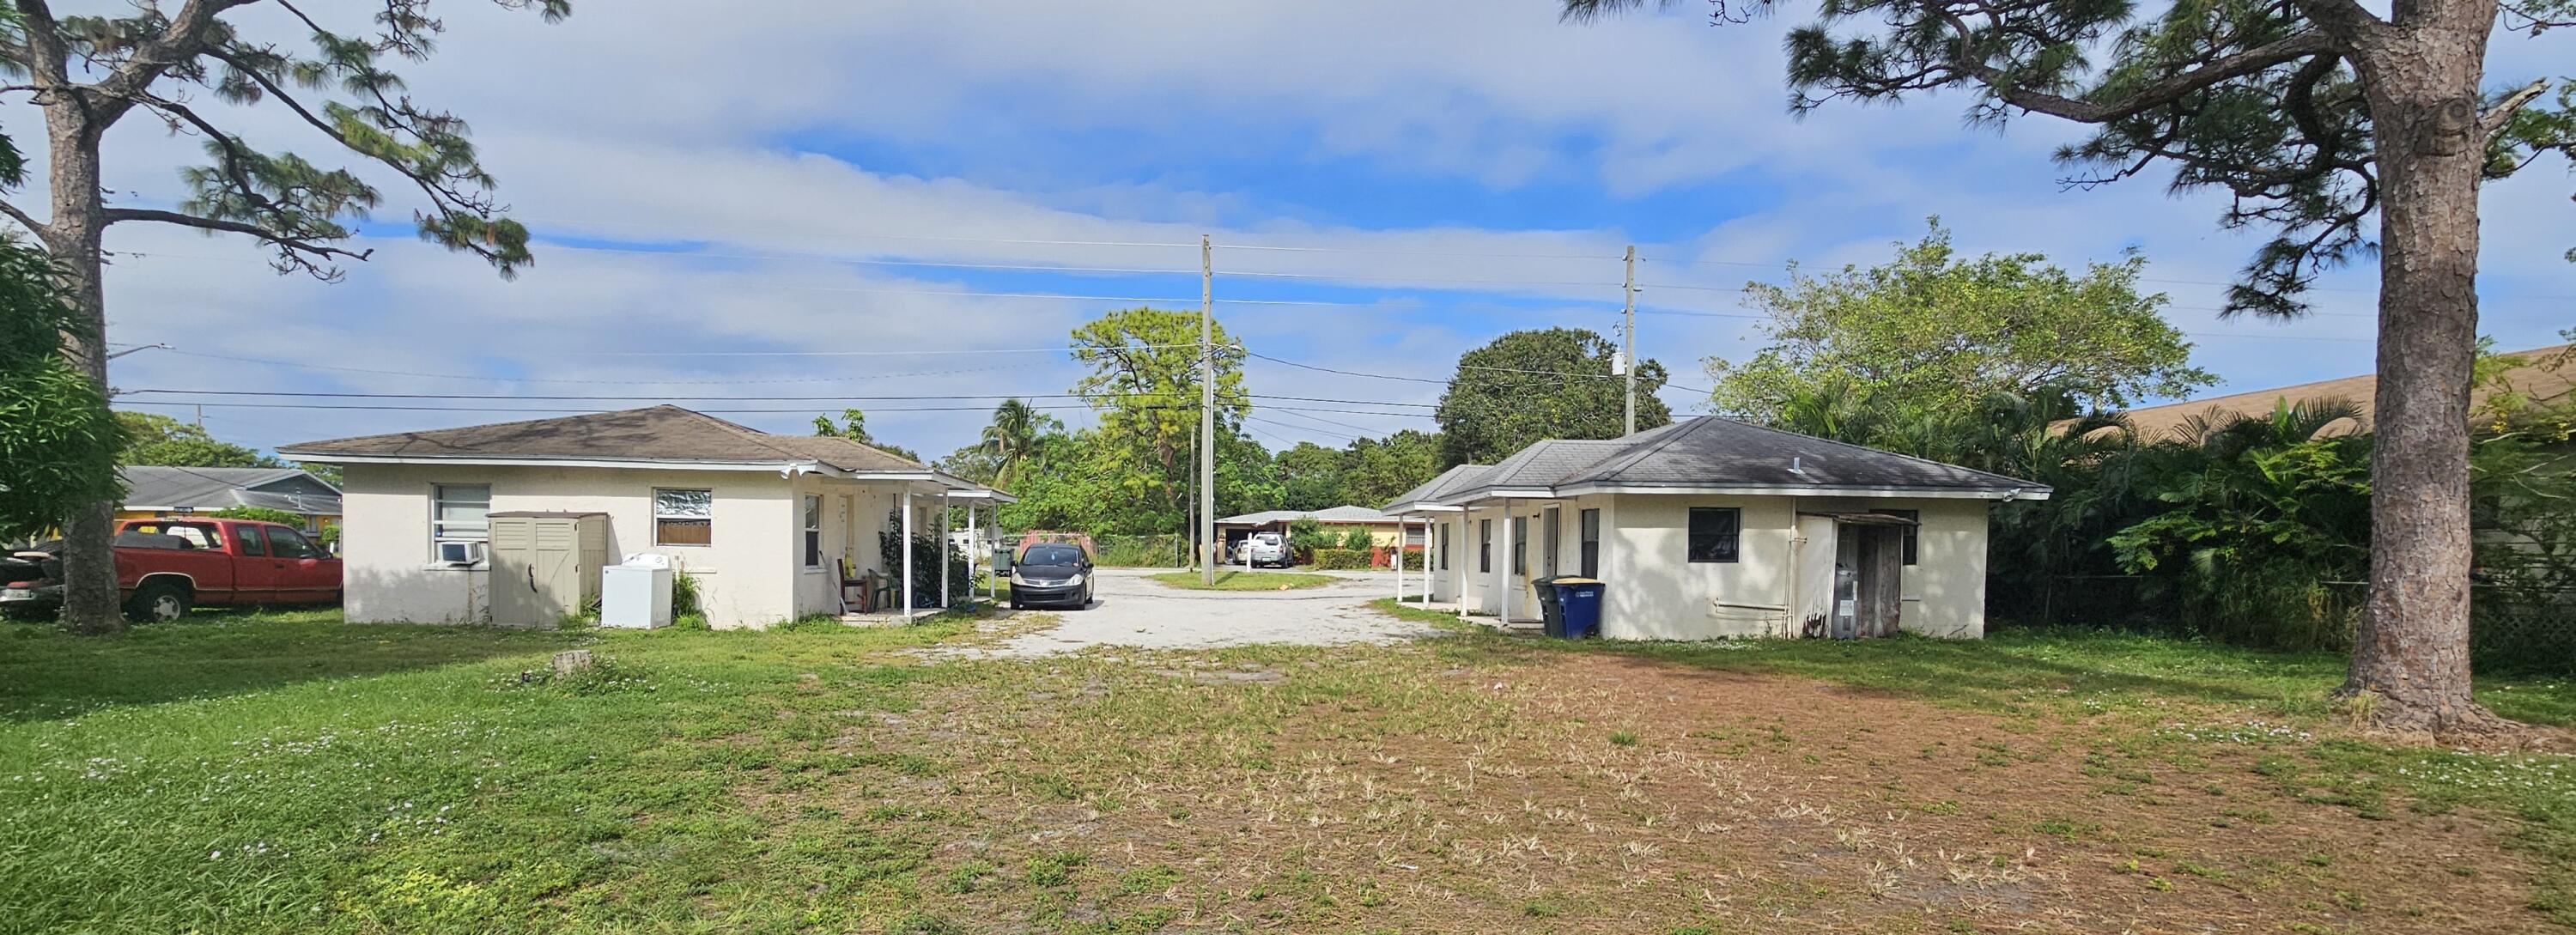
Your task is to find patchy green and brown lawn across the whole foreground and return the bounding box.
[15,610,2576,932]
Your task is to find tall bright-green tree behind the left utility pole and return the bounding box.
[1072,309,1249,531]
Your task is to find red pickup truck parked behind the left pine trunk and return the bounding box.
[0,518,340,621]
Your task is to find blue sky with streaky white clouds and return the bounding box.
[35,0,2576,466]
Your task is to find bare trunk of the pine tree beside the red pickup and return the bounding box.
[39,95,126,634]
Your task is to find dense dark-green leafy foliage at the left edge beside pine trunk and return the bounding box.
[0,228,126,554]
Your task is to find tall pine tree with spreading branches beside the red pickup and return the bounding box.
[0,0,572,631]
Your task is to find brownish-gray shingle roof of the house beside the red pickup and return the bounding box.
[278,407,925,471]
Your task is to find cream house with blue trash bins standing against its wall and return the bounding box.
[1386,417,2048,639]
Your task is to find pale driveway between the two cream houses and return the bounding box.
[979,569,1430,657]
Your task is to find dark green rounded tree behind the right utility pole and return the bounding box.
[1432,327,1672,469]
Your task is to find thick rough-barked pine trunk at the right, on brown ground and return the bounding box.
[2344,18,2501,737]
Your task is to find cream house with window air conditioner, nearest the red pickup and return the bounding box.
[278,407,1010,626]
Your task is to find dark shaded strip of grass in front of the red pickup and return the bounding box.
[0,610,577,721]
